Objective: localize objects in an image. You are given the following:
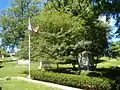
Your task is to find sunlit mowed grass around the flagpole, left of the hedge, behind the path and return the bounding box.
[0,61,39,78]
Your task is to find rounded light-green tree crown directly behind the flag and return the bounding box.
[17,11,84,60]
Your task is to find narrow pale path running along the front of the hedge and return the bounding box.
[12,77,82,90]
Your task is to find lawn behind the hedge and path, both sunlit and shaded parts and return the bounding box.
[0,57,120,86]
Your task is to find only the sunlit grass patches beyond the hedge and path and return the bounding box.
[0,57,120,78]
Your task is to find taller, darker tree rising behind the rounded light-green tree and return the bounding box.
[45,0,110,56]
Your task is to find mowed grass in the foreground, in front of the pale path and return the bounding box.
[0,79,60,90]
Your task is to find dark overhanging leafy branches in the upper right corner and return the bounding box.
[94,0,120,38]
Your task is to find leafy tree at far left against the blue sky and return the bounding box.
[0,0,40,48]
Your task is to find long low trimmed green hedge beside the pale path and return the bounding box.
[24,71,116,90]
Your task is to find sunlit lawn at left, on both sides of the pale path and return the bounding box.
[0,61,60,90]
